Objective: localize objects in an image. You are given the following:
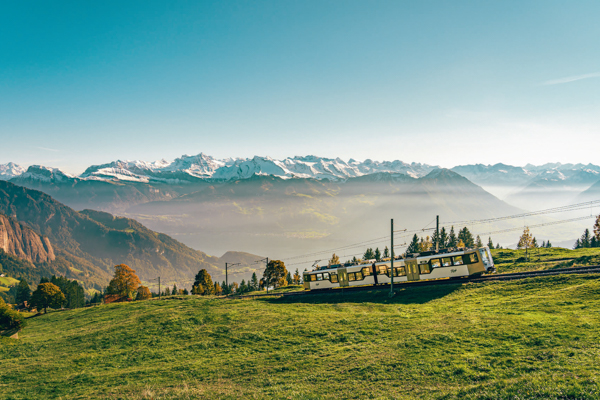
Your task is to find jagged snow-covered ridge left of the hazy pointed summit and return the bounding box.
[0,153,437,183]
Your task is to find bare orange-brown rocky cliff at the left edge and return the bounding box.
[0,214,55,263]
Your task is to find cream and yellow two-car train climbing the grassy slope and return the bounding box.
[303,246,496,290]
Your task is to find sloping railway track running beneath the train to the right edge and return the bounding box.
[232,265,600,299]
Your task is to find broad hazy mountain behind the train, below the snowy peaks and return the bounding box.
[126,170,517,260]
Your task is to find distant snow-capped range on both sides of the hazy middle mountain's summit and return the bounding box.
[0,153,600,211]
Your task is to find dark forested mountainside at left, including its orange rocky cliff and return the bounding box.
[0,181,261,289]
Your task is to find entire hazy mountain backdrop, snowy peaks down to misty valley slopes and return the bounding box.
[0,153,600,268]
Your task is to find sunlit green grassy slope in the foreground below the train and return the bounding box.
[0,275,600,399]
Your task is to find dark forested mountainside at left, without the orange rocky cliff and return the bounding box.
[0,181,220,286]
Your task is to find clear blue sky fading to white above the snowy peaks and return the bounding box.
[0,0,600,173]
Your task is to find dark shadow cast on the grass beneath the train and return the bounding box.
[257,283,462,304]
